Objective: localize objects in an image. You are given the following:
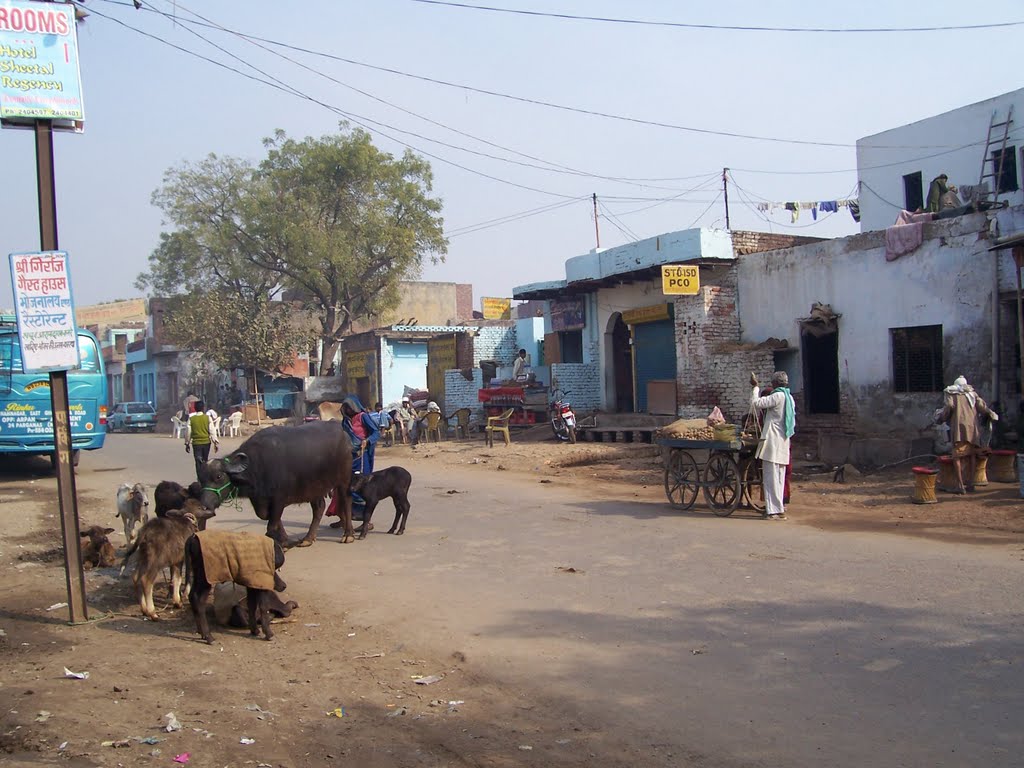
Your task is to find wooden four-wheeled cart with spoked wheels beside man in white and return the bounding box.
[657,437,765,517]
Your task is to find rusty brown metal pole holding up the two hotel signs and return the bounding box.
[36,120,89,624]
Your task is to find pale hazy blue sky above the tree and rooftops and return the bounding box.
[0,0,1024,307]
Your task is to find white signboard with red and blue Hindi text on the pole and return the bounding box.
[10,251,79,373]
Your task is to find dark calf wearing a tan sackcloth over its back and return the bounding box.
[185,530,287,643]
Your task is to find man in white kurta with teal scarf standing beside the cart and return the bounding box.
[751,371,797,520]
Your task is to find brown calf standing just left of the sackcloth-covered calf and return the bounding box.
[121,499,213,622]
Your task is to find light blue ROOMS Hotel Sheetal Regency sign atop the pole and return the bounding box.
[0,0,85,122]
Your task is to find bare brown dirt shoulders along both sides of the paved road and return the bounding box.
[0,440,1024,768]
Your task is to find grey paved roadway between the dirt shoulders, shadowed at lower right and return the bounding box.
[25,434,1024,768]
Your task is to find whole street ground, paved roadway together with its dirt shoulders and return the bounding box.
[0,435,1024,766]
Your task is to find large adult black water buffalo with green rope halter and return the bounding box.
[200,421,355,547]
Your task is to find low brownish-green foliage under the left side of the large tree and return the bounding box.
[164,292,316,372]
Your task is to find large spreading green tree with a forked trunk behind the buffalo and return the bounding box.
[138,125,447,375]
